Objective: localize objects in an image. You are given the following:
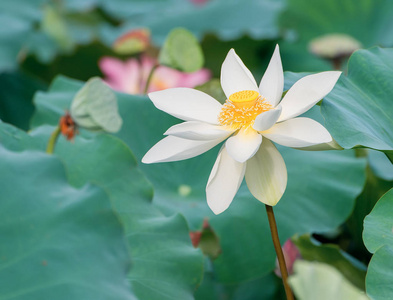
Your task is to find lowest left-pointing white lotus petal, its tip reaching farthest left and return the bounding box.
[142,136,224,164]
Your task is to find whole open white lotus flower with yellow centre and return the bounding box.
[142,45,341,214]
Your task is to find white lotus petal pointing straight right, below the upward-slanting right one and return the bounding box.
[262,118,332,148]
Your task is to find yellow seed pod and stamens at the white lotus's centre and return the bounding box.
[218,90,273,130]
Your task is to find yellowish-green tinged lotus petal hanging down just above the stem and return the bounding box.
[246,139,288,206]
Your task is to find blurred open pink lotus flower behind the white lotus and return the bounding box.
[99,56,211,94]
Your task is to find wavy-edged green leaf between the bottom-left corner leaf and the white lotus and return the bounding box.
[32,126,203,300]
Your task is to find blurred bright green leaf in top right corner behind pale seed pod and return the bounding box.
[279,0,393,72]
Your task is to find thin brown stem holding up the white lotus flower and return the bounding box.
[265,205,294,300]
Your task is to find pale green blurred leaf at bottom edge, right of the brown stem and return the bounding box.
[288,260,368,300]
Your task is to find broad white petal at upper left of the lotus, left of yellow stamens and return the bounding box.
[149,88,222,124]
